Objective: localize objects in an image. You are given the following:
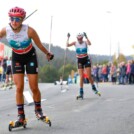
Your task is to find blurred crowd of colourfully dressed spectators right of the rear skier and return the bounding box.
[92,60,134,85]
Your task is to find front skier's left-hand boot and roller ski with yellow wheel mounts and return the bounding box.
[9,114,27,131]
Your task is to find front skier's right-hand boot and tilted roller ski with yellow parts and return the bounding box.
[35,108,51,127]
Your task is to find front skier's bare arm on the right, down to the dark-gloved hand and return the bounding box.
[28,27,53,60]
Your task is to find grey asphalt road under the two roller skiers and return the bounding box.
[0,83,134,134]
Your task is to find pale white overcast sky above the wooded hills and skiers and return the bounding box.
[0,0,134,55]
